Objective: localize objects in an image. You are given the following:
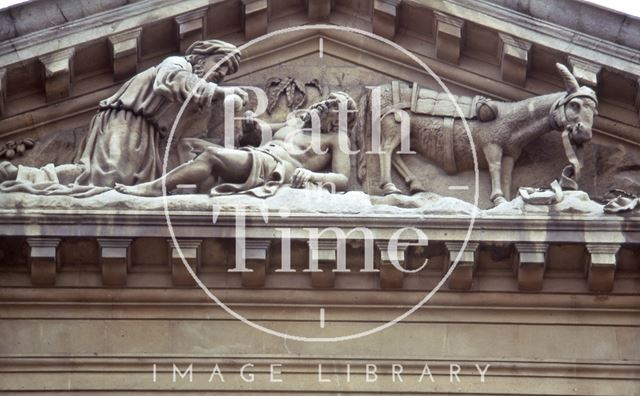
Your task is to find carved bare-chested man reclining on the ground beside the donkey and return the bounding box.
[115,92,356,197]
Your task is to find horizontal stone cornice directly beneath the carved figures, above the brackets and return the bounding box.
[0,210,640,243]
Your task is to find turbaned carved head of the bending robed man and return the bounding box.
[185,40,240,83]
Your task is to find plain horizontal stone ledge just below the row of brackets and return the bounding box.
[0,287,640,310]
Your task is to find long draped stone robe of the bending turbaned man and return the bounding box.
[0,57,221,196]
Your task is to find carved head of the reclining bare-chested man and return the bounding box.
[303,91,358,133]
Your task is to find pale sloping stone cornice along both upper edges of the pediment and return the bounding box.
[0,0,640,76]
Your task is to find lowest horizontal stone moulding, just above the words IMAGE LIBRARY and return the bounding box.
[0,354,640,379]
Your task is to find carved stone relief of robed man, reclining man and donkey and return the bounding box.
[2,40,638,215]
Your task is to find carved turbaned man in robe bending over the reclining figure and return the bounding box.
[74,40,247,187]
